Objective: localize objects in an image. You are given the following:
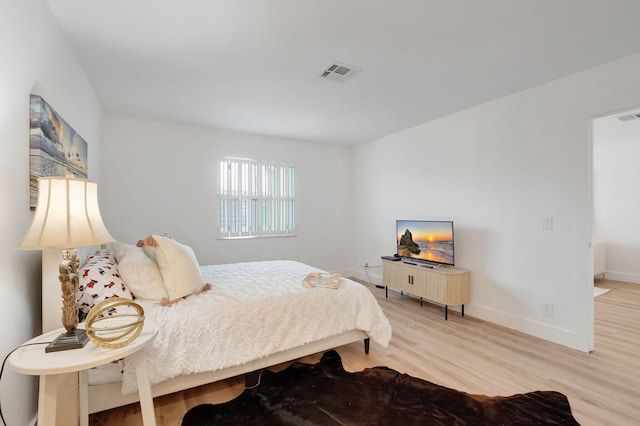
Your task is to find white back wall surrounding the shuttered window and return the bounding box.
[101,116,353,271]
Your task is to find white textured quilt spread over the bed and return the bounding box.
[122,261,391,394]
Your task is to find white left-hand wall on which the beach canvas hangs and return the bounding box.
[0,0,102,425]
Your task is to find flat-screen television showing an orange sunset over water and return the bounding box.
[396,220,455,266]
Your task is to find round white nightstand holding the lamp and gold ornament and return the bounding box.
[8,320,158,426]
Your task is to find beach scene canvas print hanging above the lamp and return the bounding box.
[29,95,88,210]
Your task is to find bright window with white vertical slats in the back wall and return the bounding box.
[218,157,295,238]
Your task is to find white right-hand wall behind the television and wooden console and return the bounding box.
[353,55,640,351]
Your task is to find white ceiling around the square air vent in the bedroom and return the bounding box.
[47,0,640,145]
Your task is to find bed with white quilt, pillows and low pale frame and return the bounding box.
[43,240,391,413]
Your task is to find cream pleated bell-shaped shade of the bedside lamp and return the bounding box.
[18,177,113,249]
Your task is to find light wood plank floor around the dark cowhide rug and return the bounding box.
[90,280,640,426]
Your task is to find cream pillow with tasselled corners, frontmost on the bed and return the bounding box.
[145,235,204,301]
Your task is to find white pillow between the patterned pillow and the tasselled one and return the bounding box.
[113,242,169,300]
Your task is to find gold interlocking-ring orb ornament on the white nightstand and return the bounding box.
[85,297,144,349]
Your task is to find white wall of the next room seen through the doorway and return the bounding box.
[593,141,640,284]
